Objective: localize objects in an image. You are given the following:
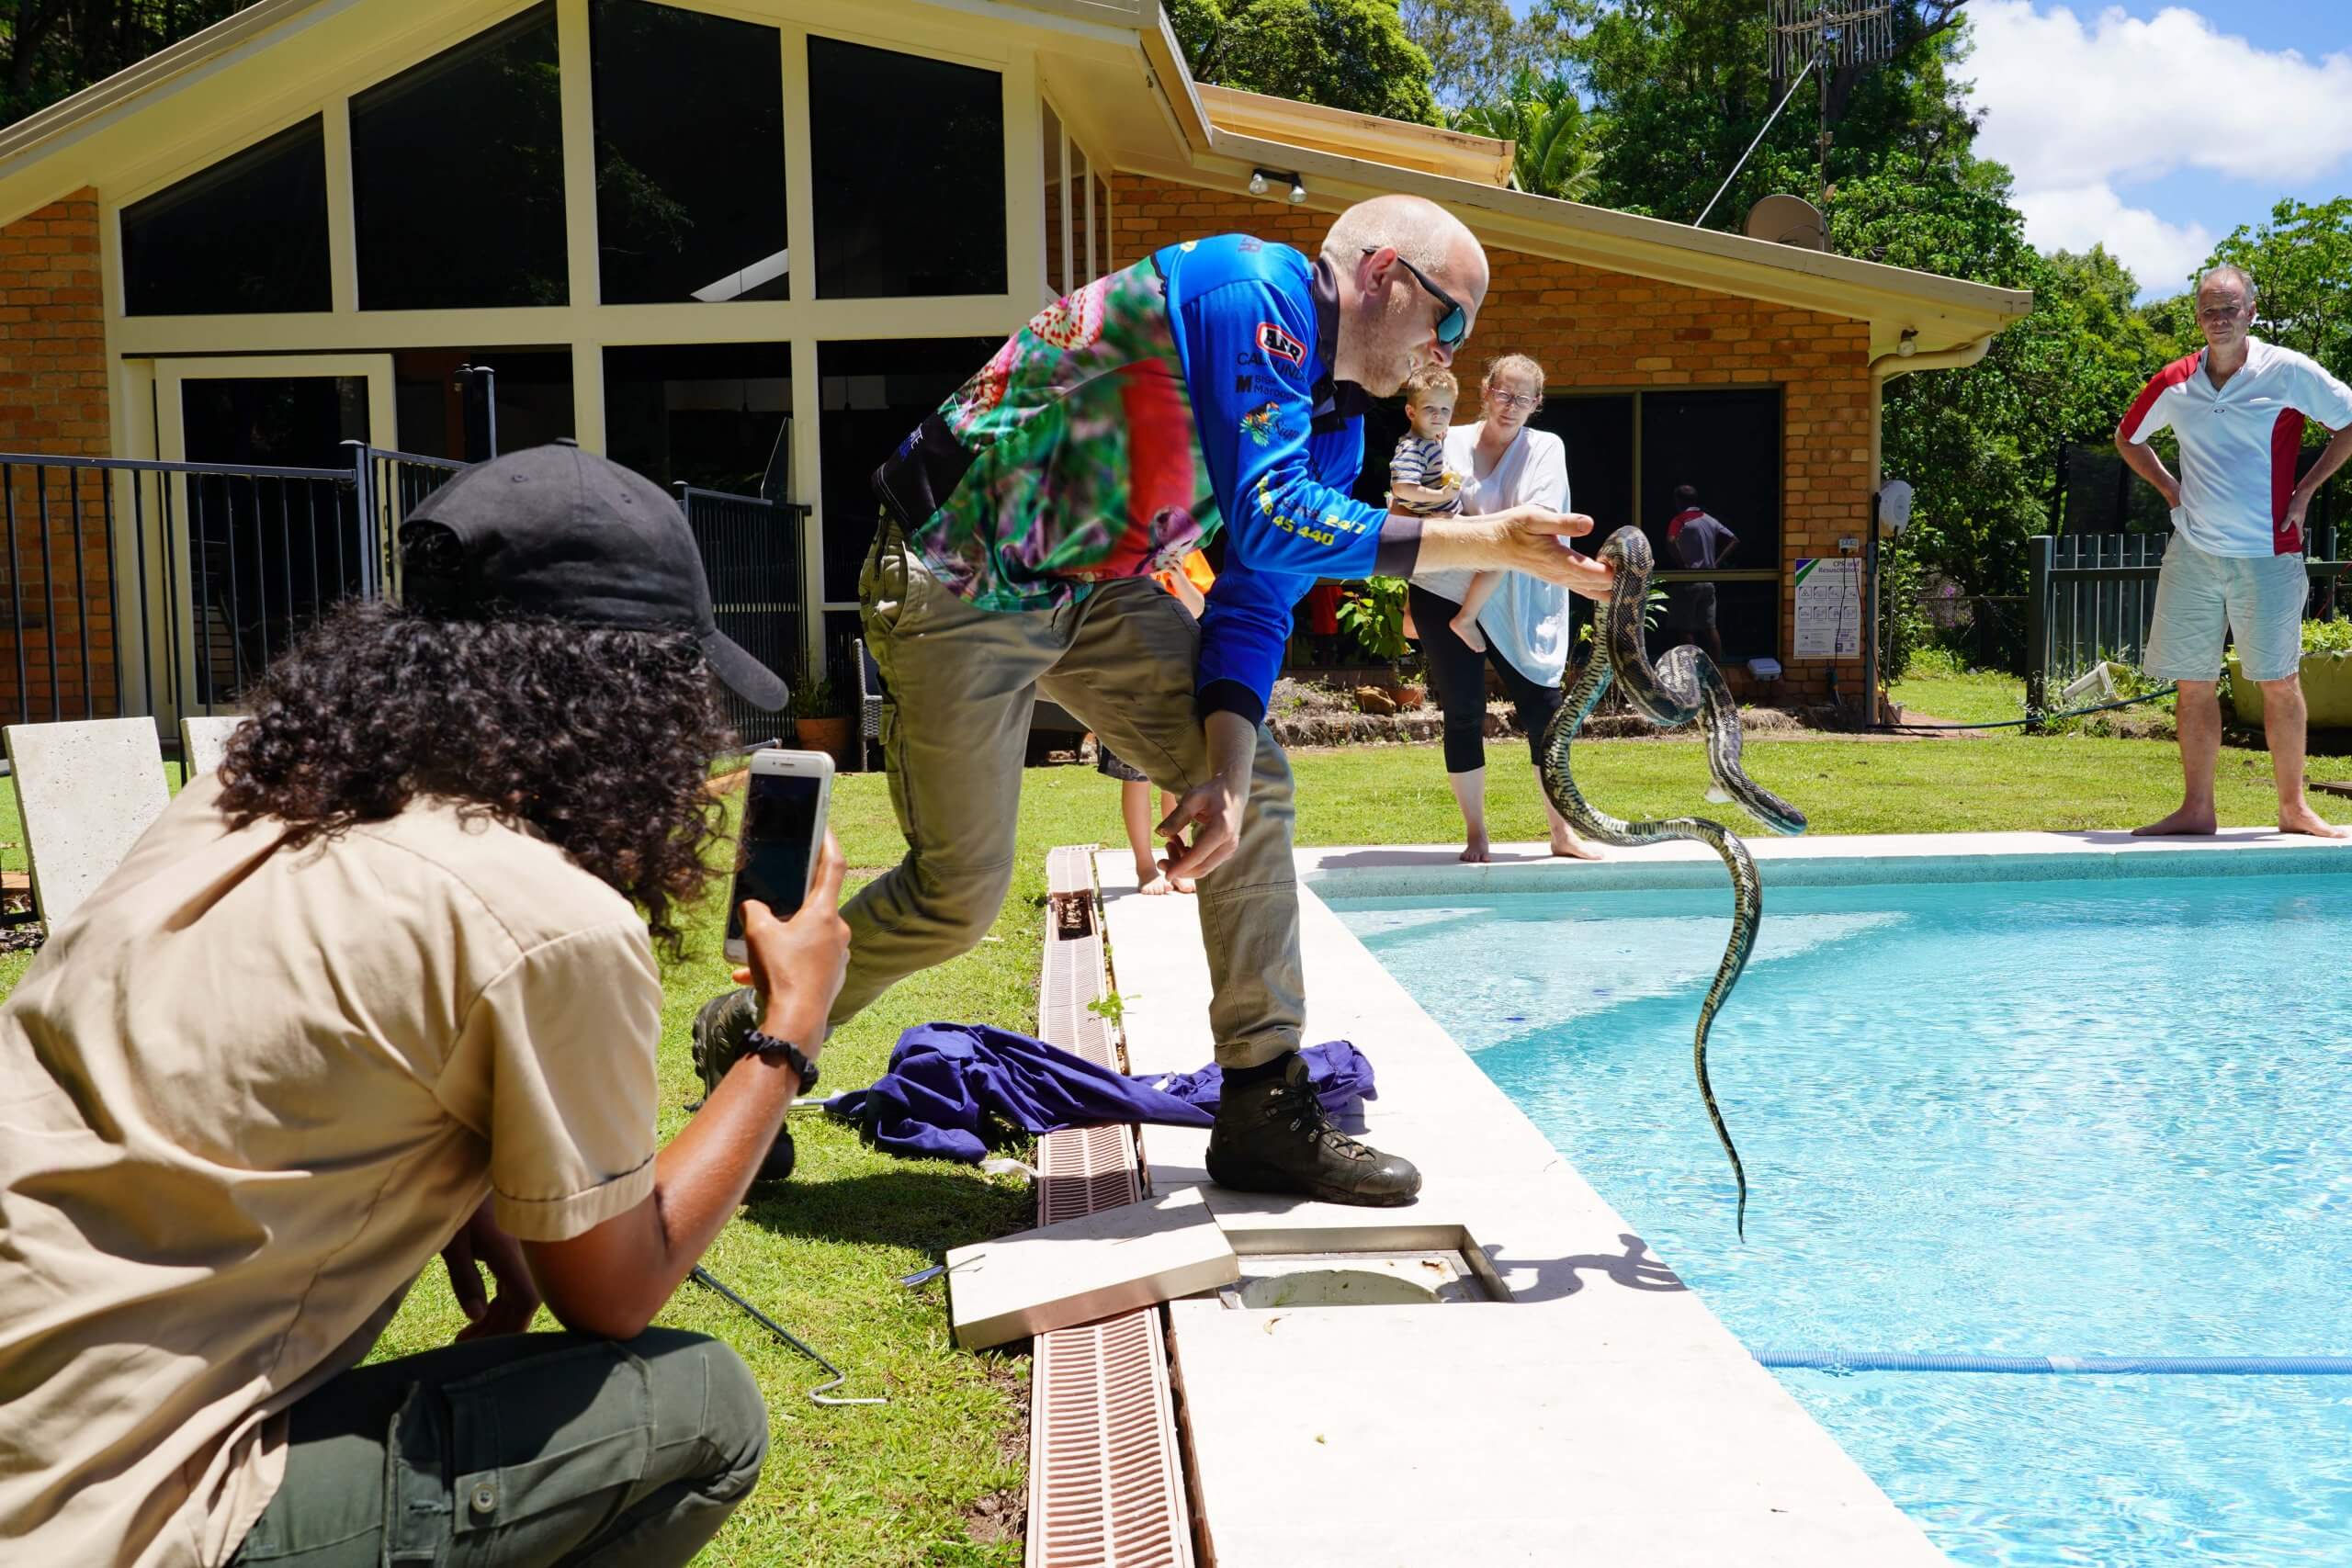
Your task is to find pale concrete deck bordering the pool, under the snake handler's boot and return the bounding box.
[1096,829,2352,1568]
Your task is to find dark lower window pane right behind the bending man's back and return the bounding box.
[816,339,1002,600]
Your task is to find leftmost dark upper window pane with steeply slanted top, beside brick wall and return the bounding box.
[122,120,334,315]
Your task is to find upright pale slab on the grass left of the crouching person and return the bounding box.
[5,719,172,931]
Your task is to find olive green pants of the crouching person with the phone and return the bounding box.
[231,1328,767,1568]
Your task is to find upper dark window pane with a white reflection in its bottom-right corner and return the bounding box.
[593,0,790,306]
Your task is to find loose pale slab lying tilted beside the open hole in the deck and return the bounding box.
[948,1187,1242,1349]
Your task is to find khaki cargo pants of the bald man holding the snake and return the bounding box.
[832,522,1306,1067]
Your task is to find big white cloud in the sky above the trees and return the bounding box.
[1962,0,2352,289]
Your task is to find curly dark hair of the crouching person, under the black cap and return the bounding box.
[221,550,734,957]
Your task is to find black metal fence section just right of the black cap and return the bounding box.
[677,484,809,740]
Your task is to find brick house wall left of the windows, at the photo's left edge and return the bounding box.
[0,188,115,719]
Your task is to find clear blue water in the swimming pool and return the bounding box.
[1331,874,2352,1568]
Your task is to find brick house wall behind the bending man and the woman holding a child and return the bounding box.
[1113,174,1872,703]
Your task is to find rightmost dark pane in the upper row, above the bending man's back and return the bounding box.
[809,38,1004,297]
